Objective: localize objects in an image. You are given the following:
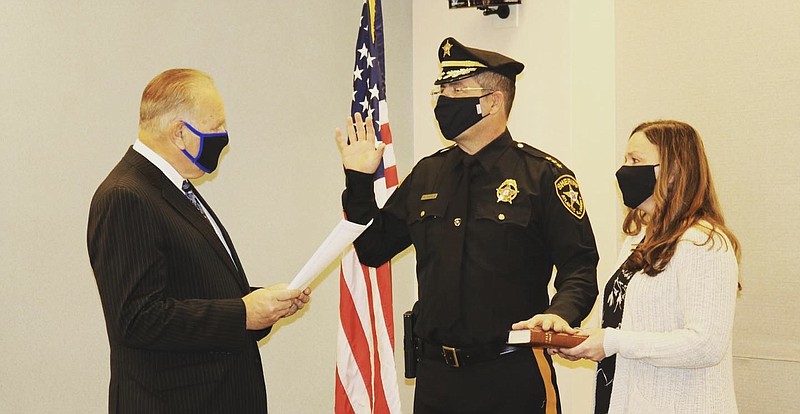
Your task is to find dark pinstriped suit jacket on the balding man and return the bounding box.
[87,148,268,414]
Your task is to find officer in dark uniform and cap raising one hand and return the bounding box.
[337,38,598,414]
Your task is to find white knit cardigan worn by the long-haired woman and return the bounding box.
[603,223,738,414]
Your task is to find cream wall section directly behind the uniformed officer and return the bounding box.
[413,0,619,414]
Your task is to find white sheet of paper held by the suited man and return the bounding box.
[289,219,372,290]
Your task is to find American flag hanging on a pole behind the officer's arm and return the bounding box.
[335,0,401,414]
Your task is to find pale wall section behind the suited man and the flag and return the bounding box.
[0,0,413,413]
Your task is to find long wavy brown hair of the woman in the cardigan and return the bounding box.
[622,120,741,278]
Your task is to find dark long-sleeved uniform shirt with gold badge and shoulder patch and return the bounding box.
[342,131,598,346]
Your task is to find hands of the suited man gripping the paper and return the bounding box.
[242,285,300,330]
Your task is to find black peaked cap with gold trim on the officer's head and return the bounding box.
[433,37,525,85]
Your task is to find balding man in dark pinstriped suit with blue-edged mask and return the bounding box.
[88,69,310,414]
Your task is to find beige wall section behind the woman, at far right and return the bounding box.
[616,0,800,413]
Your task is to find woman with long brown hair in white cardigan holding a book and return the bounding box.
[551,121,739,414]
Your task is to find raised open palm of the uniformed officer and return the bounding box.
[336,113,386,174]
